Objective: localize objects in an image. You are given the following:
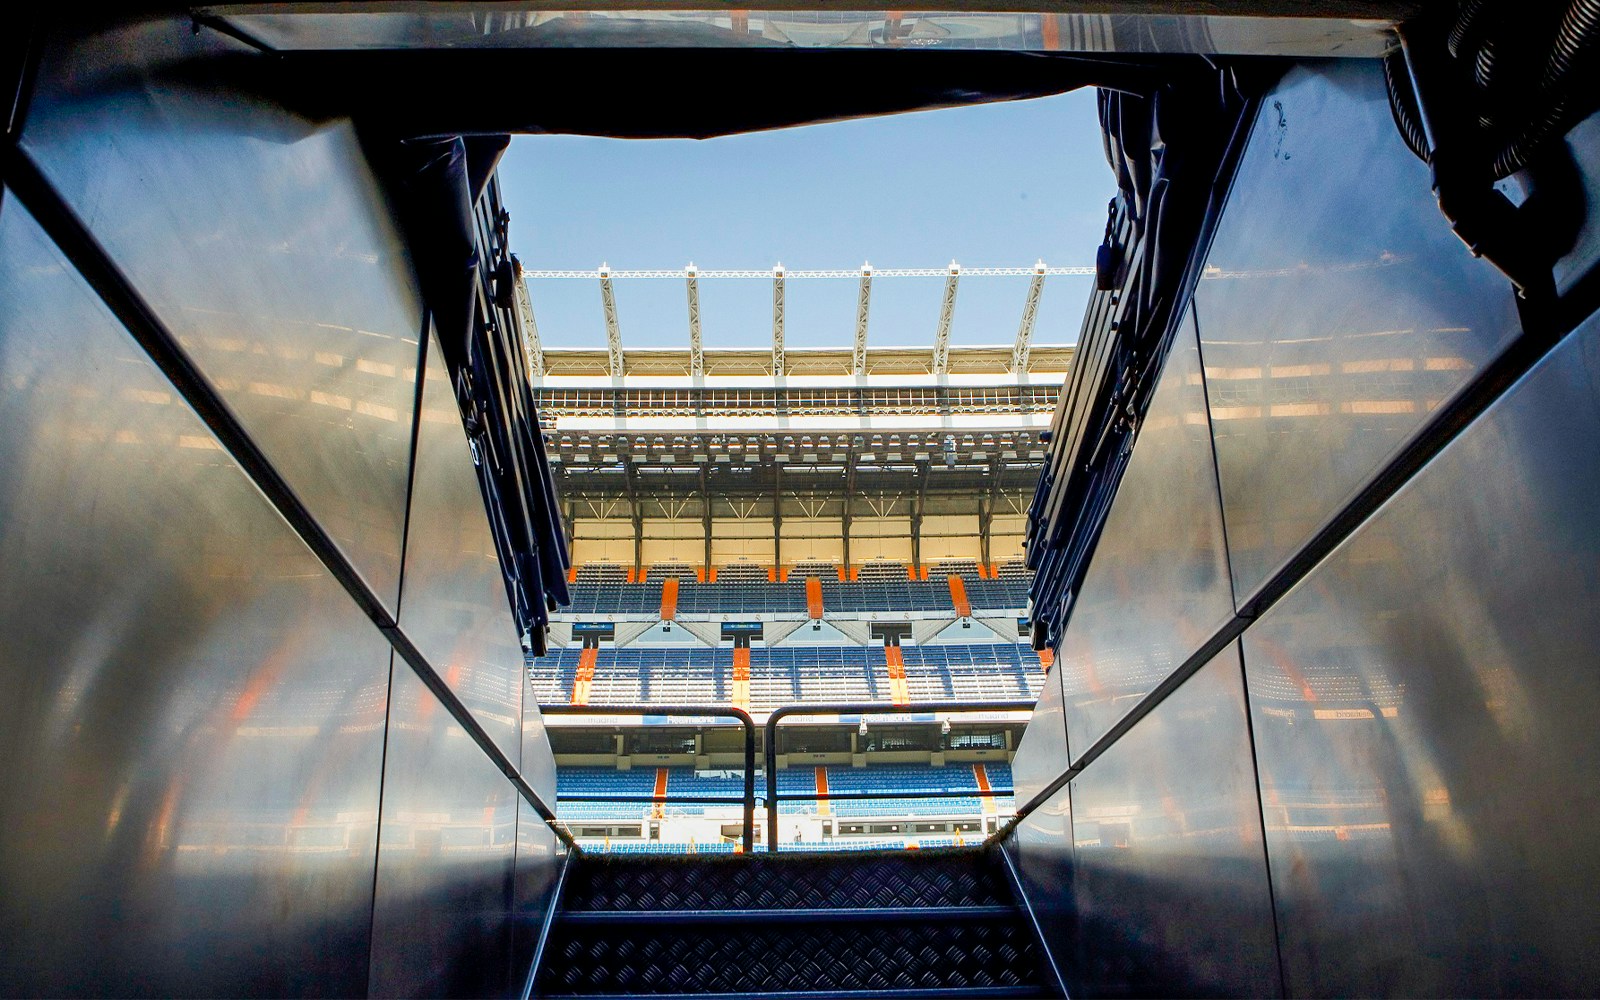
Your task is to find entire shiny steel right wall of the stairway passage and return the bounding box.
[1010,56,1600,995]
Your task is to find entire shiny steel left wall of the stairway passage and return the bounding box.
[0,18,560,995]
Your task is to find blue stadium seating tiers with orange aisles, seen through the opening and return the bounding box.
[528,560,1051,853]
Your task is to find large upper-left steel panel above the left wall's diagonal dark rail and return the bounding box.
[24,16,422,610]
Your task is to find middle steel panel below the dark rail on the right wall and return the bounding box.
[1062,645,1280,997]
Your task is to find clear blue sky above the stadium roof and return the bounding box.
[501,91,1115,347]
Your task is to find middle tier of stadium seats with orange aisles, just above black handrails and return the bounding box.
[528,643,1043,712]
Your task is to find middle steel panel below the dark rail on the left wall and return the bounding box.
[370,664,522,997]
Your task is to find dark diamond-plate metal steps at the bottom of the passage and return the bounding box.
[536,848,1056,997]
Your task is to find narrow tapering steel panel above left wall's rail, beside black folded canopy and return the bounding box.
[400,333,528,762]
